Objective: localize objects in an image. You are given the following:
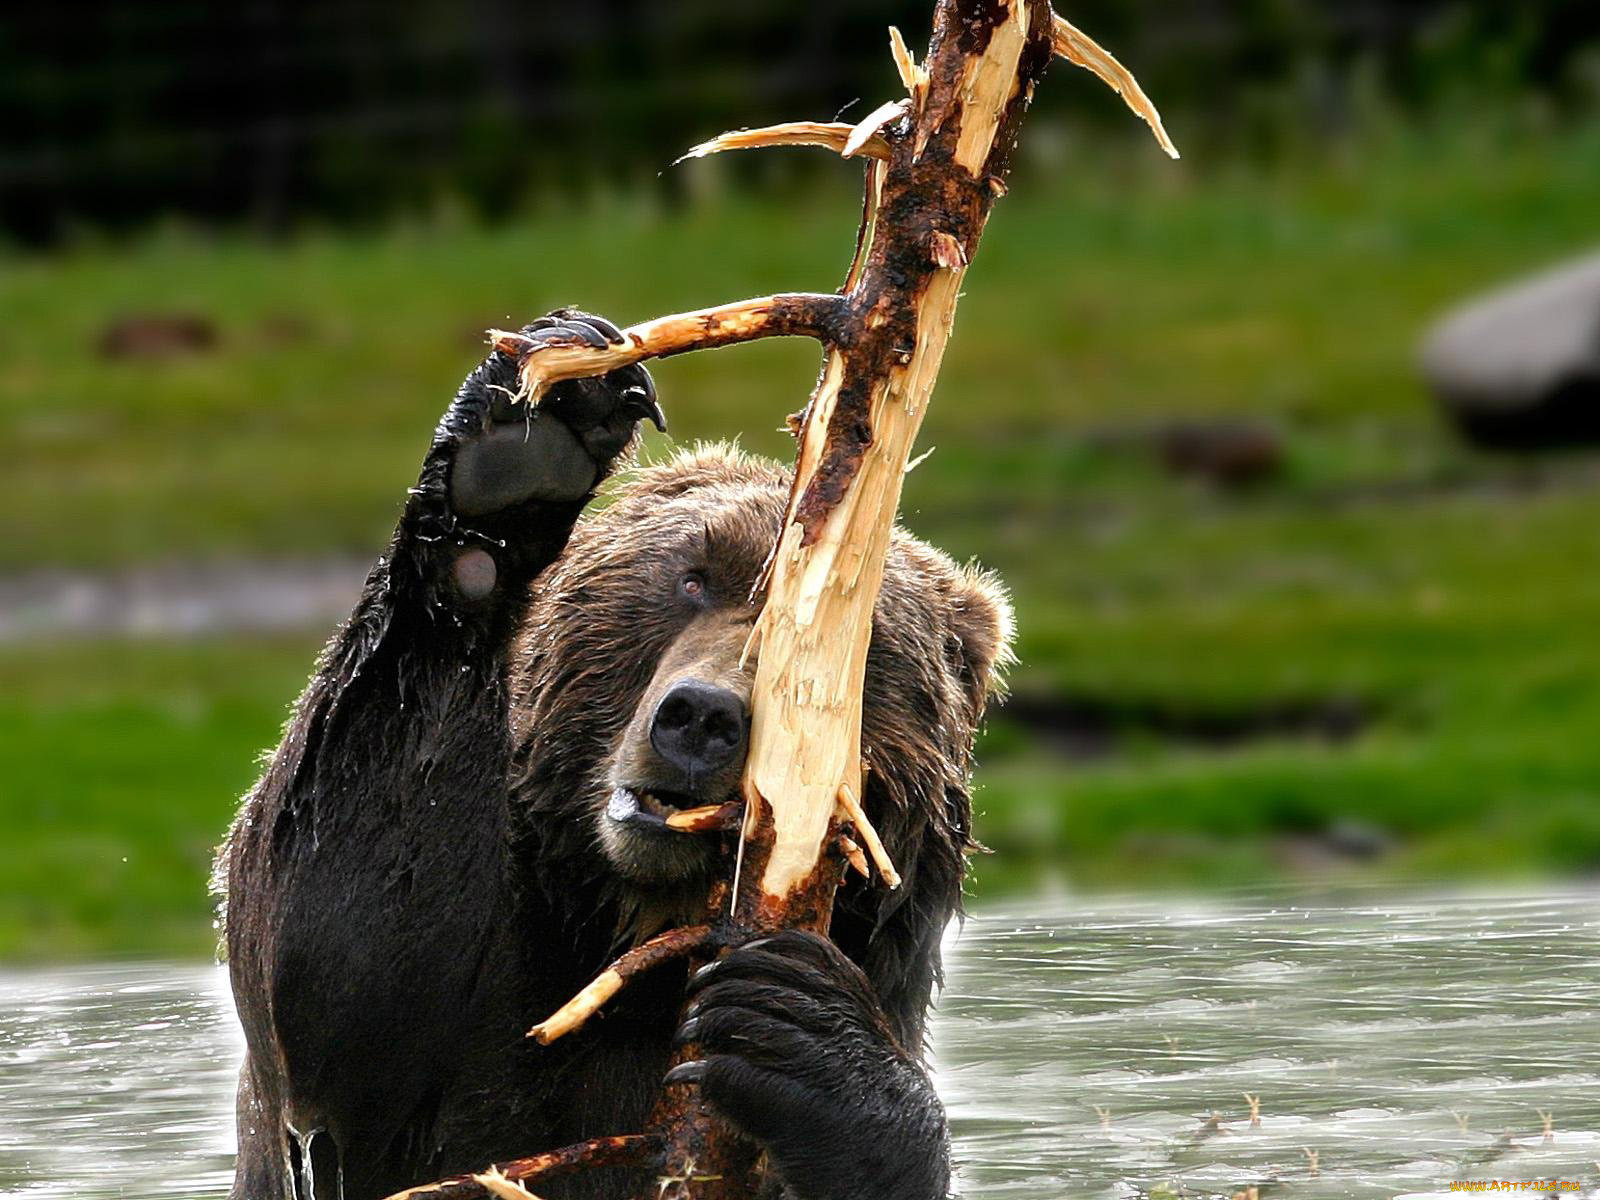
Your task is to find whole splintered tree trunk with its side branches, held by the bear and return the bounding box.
[380,0,1178,1200]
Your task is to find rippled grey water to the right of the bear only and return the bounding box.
[936,894,1600,1200]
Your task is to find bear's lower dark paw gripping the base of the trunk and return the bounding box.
[666,931,949,1200]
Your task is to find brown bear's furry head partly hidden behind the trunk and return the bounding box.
[512,446,1011,928]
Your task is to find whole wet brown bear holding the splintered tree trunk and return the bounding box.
[218,310,1010,1200]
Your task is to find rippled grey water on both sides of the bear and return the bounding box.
[0,893,1600,1200]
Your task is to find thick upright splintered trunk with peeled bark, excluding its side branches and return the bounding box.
[736,0,1051,925]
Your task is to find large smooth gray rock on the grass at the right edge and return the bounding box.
[1422,253,1600,450]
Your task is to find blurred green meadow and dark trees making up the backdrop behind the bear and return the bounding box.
[0,0,1600,960]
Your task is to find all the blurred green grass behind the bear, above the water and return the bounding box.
[0,112,1600,957]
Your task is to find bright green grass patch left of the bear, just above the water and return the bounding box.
[0,638,317,958]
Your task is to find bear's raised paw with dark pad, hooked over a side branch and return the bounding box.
[435,309,666,517]
